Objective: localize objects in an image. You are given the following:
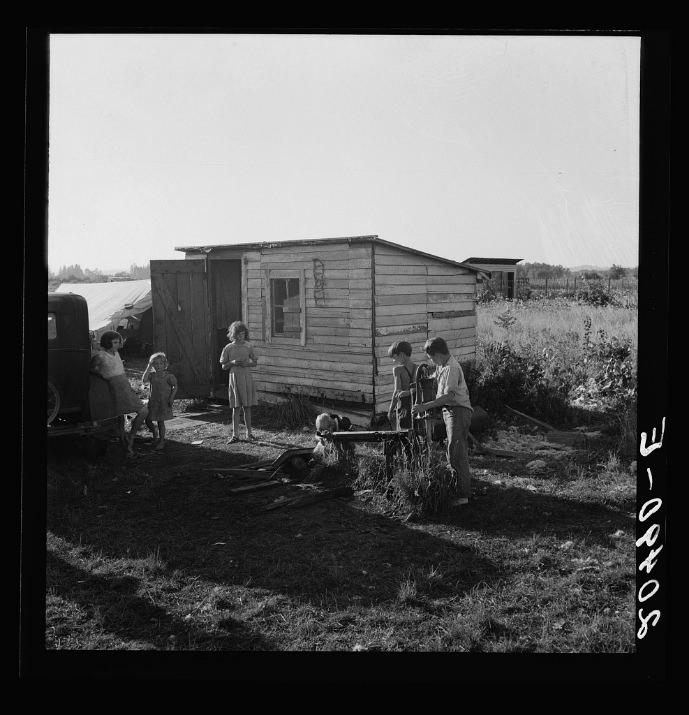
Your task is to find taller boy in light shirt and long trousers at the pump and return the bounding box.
[412,338,474,506]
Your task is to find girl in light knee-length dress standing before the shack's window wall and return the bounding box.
[220,320,258,443]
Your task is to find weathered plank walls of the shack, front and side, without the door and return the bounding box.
[180,237,476,412]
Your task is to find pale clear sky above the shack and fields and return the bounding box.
[47,32,641,272]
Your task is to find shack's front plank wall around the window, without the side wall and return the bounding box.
[217,241,373,405]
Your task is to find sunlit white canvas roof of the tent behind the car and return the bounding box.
[55,278,152,336]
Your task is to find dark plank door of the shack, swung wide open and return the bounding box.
[150,259,212,398]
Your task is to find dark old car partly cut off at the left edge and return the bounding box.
[48,293,117,450]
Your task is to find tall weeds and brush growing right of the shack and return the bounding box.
[465,298,637,420]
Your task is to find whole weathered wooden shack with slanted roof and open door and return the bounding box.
[150,236,480,422]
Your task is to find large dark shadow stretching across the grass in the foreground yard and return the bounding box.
[47,441,495,609]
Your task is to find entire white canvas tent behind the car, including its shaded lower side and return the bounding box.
[55,278,152,345]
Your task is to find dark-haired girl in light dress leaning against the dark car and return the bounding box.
[90,330,148,456]
